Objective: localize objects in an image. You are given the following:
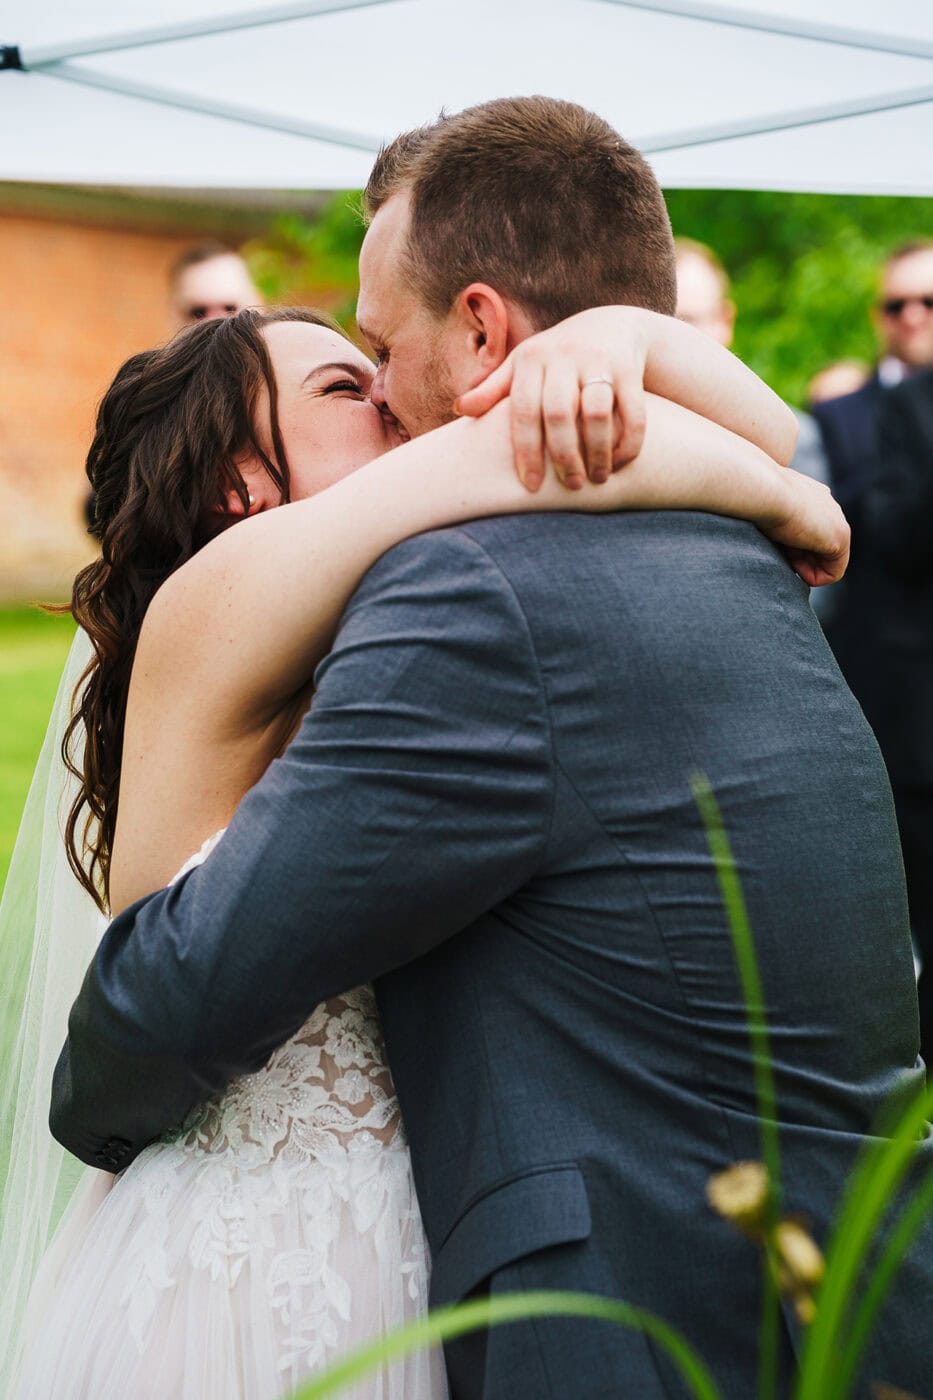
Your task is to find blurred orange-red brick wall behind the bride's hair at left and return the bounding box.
[0,214,205,601]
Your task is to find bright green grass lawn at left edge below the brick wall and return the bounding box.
[0,608,74,886]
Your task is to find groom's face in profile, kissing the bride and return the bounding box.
[357,193,459,437]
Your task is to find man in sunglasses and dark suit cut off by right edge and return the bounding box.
[813,239,933,1065]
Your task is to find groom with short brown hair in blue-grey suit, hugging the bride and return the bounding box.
[52,98,933,1400]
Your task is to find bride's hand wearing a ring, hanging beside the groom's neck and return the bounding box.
[455,307,647,491]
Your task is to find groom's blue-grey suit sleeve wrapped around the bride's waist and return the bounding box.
[50,531,553,1169]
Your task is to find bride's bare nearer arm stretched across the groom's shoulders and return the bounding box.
[111,399,846,911]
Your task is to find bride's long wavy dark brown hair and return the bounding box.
[63,307,338,911]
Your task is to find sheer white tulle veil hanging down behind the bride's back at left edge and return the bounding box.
[0,630,105,1397]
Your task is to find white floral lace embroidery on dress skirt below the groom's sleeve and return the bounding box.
[118,987,426,1373]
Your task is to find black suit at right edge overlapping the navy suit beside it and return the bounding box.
[862,372,933,1063]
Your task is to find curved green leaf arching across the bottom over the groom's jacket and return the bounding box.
[282,1292,721,1400]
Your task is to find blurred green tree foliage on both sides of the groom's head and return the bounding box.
[248,189,933,405]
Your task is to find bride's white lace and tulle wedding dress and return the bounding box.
[14,837,447,1400]
